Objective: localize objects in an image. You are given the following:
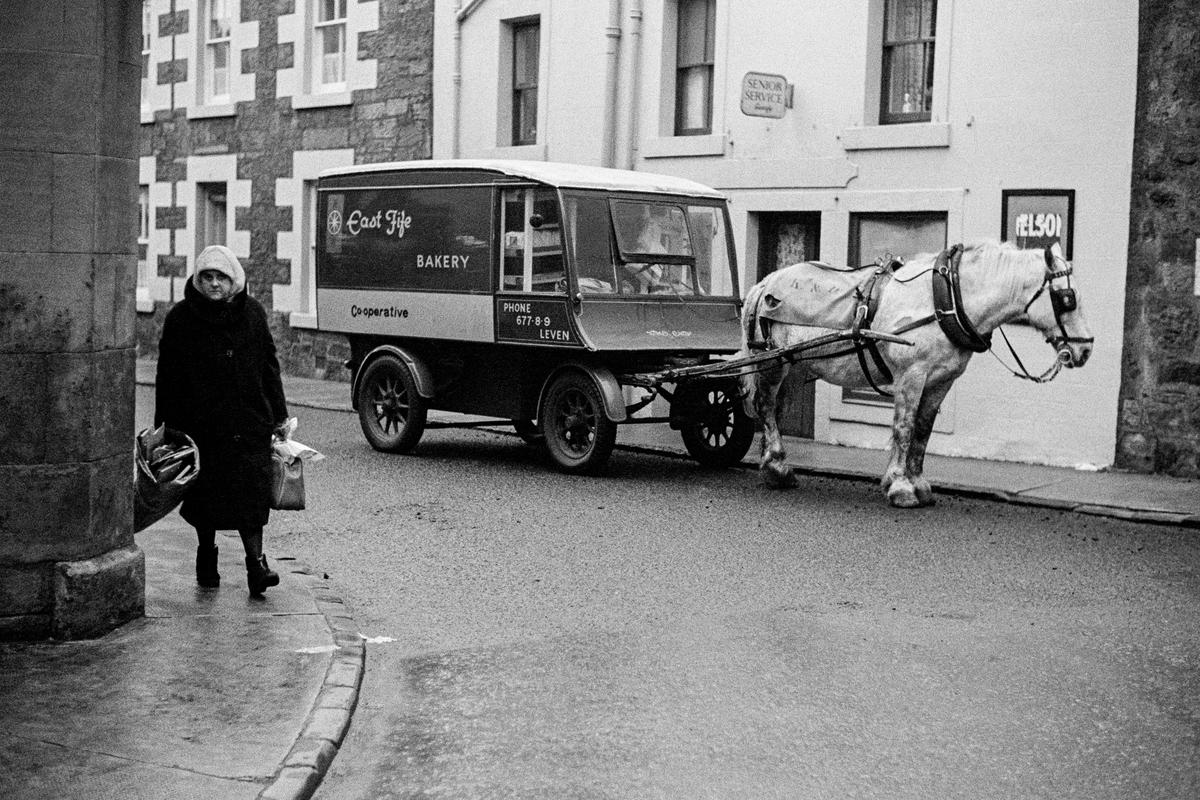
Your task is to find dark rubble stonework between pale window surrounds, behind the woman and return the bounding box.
[137,0,433,379]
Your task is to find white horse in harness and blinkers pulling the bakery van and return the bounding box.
[739,241,1094,507]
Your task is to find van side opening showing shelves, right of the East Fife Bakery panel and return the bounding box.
[500,188,566,294]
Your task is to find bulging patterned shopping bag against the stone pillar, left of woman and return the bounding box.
[133,426,200,533]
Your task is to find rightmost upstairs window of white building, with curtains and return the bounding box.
[880,0,937,125]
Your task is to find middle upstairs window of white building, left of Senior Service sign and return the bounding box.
[674,0,716,136]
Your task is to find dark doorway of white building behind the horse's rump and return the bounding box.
[755,211,821,439]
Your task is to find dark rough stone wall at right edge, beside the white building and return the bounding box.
[1116,0,1200,477]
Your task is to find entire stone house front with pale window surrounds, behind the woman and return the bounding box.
[137,0,433,378]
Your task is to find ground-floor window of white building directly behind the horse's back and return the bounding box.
[841,211,947,405]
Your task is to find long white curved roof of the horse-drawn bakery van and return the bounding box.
[320,158,725,198]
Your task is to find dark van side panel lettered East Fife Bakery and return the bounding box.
[317,186,492,291]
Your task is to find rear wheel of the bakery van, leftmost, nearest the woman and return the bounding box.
[358,355,428,452]
